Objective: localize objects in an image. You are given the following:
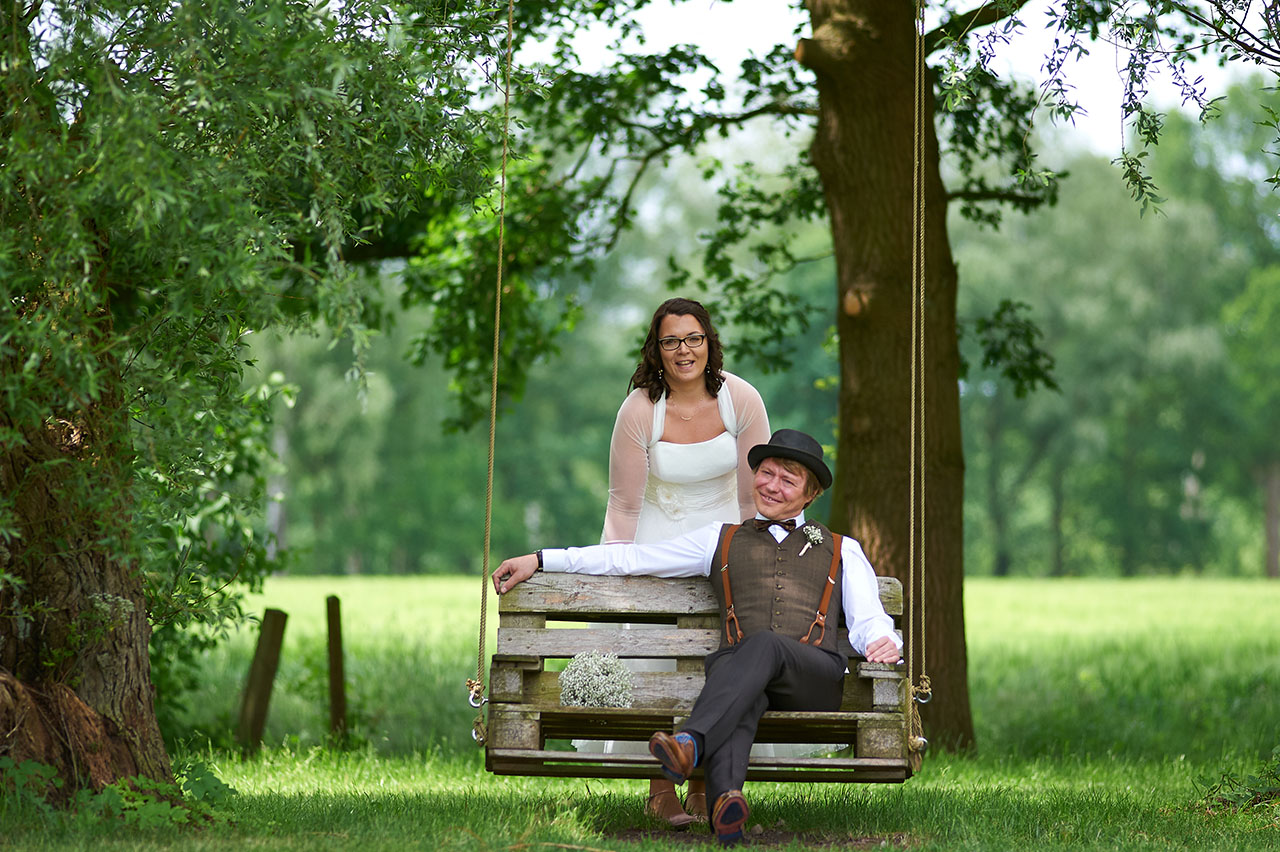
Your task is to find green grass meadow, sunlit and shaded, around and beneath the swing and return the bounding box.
[0,577,1280,851]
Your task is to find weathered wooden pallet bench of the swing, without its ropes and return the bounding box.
[485,573,911,782]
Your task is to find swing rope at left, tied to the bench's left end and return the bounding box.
[467,0,516,746]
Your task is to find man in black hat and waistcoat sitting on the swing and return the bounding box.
[493,429,901,844]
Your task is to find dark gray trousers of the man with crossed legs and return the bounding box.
[682,631,845,807]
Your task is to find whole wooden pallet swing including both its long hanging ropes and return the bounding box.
[467,0,931,783]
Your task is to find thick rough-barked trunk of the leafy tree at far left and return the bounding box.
[0,354,173,800]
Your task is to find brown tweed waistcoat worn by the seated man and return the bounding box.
[710,521,845,652]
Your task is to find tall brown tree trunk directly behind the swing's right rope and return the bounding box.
[796,0,973,748]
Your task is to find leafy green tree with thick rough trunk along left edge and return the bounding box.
[0,0,501,794]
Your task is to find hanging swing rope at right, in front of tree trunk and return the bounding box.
[906,0,933,771]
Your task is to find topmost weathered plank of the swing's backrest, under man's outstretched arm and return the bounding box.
[498,572,902,622]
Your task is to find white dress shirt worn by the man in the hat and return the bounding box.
[543,512,902,654]
